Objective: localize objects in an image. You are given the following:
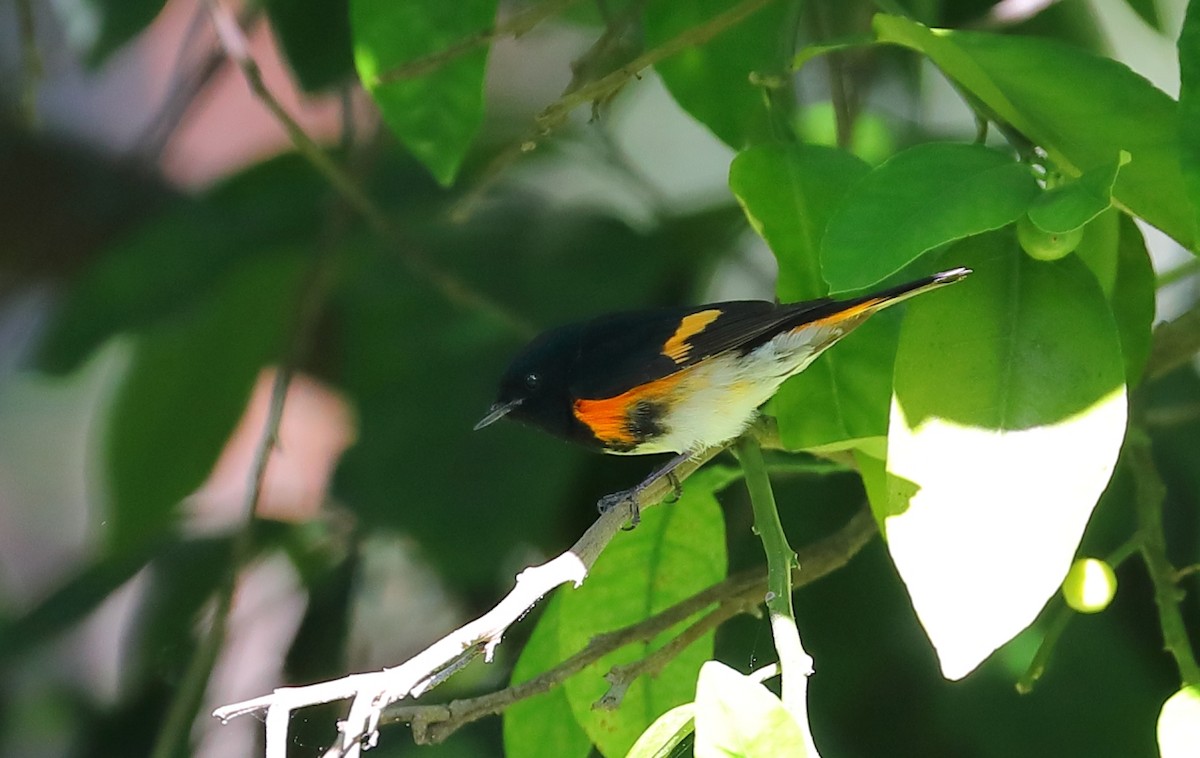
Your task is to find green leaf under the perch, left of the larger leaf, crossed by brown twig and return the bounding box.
[504,590,592,758]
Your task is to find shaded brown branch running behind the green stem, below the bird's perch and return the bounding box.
[384,507,878,745]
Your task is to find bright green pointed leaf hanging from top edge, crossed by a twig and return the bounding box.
[350,0,497,186]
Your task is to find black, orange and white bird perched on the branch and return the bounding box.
[475,269,971,524]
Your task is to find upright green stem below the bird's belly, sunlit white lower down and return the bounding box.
[737,433,817,756]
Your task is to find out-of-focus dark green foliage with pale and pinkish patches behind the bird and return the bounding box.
[0,0,1200,757]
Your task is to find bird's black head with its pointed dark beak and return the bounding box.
[475,324,582,439]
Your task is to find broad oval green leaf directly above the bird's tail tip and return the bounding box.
[821,143,1038,293]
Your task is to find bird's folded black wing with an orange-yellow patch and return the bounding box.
[571,300,834,398]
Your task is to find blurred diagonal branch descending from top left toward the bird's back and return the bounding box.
[205,0,534,337]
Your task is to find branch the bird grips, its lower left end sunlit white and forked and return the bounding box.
[212,447,724,758]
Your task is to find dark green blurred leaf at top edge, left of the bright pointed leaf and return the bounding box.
[264,0,354,92]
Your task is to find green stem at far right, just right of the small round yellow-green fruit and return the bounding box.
[1126,428,1200,686]
